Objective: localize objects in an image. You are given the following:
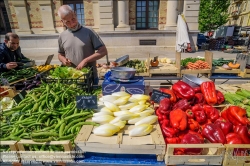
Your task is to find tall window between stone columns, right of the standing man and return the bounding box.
[136,0,159,30]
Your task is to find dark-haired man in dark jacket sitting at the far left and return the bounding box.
[0,32,27,72]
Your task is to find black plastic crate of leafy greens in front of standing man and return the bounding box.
[42,67,94,92]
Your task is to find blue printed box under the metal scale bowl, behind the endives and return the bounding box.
[102,76,145,95]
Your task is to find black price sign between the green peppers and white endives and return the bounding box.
[76,95,97,109]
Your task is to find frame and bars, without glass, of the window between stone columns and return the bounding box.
[135,0,160,30]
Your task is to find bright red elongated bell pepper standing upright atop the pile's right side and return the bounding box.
[201,81,217,105]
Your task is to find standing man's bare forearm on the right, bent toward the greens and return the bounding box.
[76,46,108,70]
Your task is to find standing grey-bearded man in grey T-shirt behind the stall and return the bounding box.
[58,5,108,85]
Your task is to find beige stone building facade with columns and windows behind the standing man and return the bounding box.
[0,0,200,57]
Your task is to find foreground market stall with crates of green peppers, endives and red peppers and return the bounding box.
[0,54,250,166]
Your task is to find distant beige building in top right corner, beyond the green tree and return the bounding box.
[227,0,250,27]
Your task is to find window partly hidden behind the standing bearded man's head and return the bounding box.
[63,0,85,25]
